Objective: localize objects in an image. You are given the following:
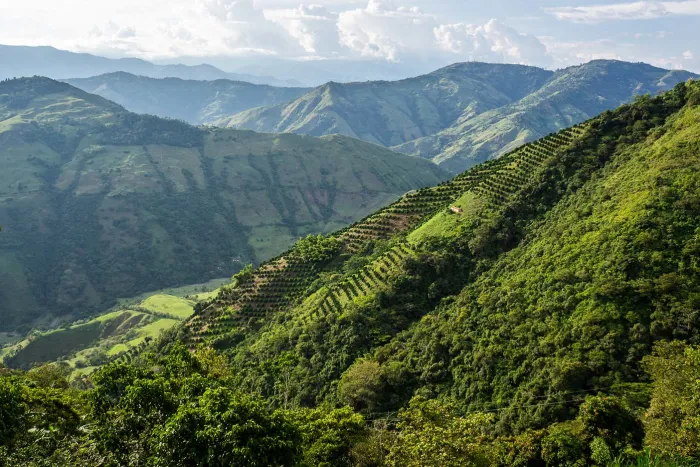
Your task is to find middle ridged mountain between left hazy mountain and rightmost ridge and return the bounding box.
[220,63,551,146]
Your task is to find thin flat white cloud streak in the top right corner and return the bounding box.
[545,0,700,23]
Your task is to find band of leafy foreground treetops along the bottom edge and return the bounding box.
[0,338,700,467]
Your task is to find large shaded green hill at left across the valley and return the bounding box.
[0,78,445,332]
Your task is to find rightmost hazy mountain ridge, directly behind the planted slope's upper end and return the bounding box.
[395,60,697,171]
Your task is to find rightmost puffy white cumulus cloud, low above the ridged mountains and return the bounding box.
[433,19,552,65]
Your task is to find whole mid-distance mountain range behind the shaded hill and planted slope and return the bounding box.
[41,60,697,176]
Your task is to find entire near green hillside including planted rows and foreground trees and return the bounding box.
[0,77,700,467]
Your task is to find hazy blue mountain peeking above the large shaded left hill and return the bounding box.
[66,72,309,125]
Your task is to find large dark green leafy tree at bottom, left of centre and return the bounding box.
[82,342,302,466]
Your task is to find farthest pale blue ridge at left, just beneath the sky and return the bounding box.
[0,45,302,87]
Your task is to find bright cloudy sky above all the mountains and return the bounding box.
[0,0,700,76]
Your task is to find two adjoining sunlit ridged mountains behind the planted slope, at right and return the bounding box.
[224,60,696,172]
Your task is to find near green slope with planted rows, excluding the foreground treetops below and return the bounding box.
[178,77,700,436]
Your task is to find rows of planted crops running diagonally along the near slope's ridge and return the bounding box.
[186,125,586,348]
